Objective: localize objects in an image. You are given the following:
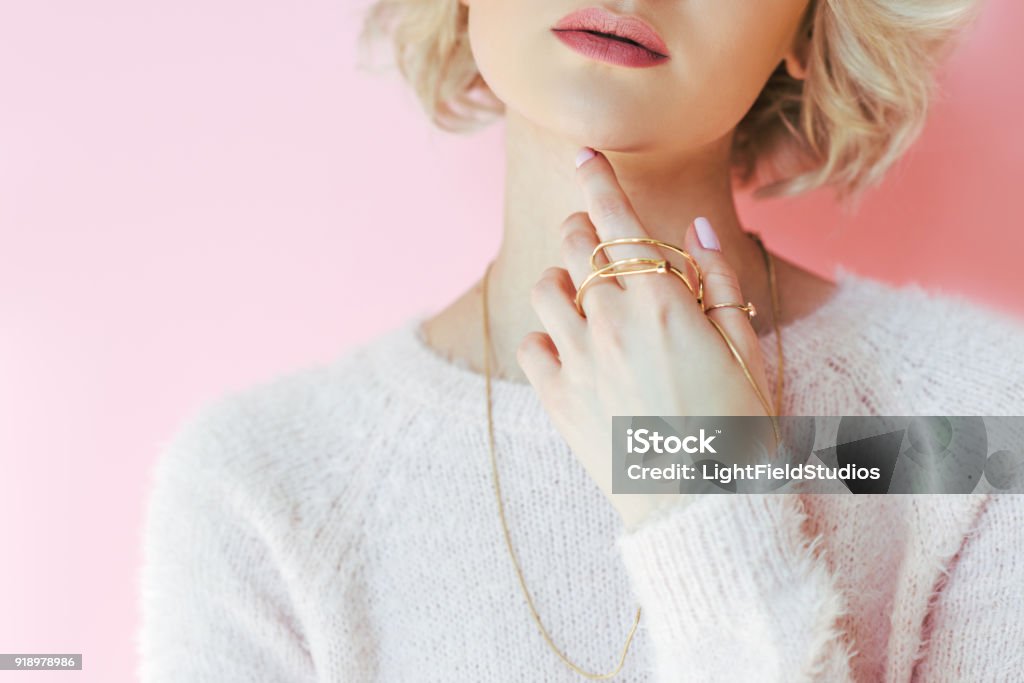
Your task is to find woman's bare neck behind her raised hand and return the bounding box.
[475,111,771,381]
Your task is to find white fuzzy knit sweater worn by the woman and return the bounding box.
[137,268,1024,683]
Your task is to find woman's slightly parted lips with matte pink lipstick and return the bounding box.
[551,7,669,69]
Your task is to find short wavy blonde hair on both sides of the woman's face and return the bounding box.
[362,0,978,197]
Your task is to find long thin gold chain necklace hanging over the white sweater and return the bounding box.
[482,232,784,680]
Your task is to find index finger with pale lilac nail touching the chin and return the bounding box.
[577,147,662,266]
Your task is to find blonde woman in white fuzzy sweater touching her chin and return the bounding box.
[140,0,1024,681]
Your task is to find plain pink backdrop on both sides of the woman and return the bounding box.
[0,0,1024,681]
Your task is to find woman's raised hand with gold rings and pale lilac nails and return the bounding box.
[516,147,770,527]
